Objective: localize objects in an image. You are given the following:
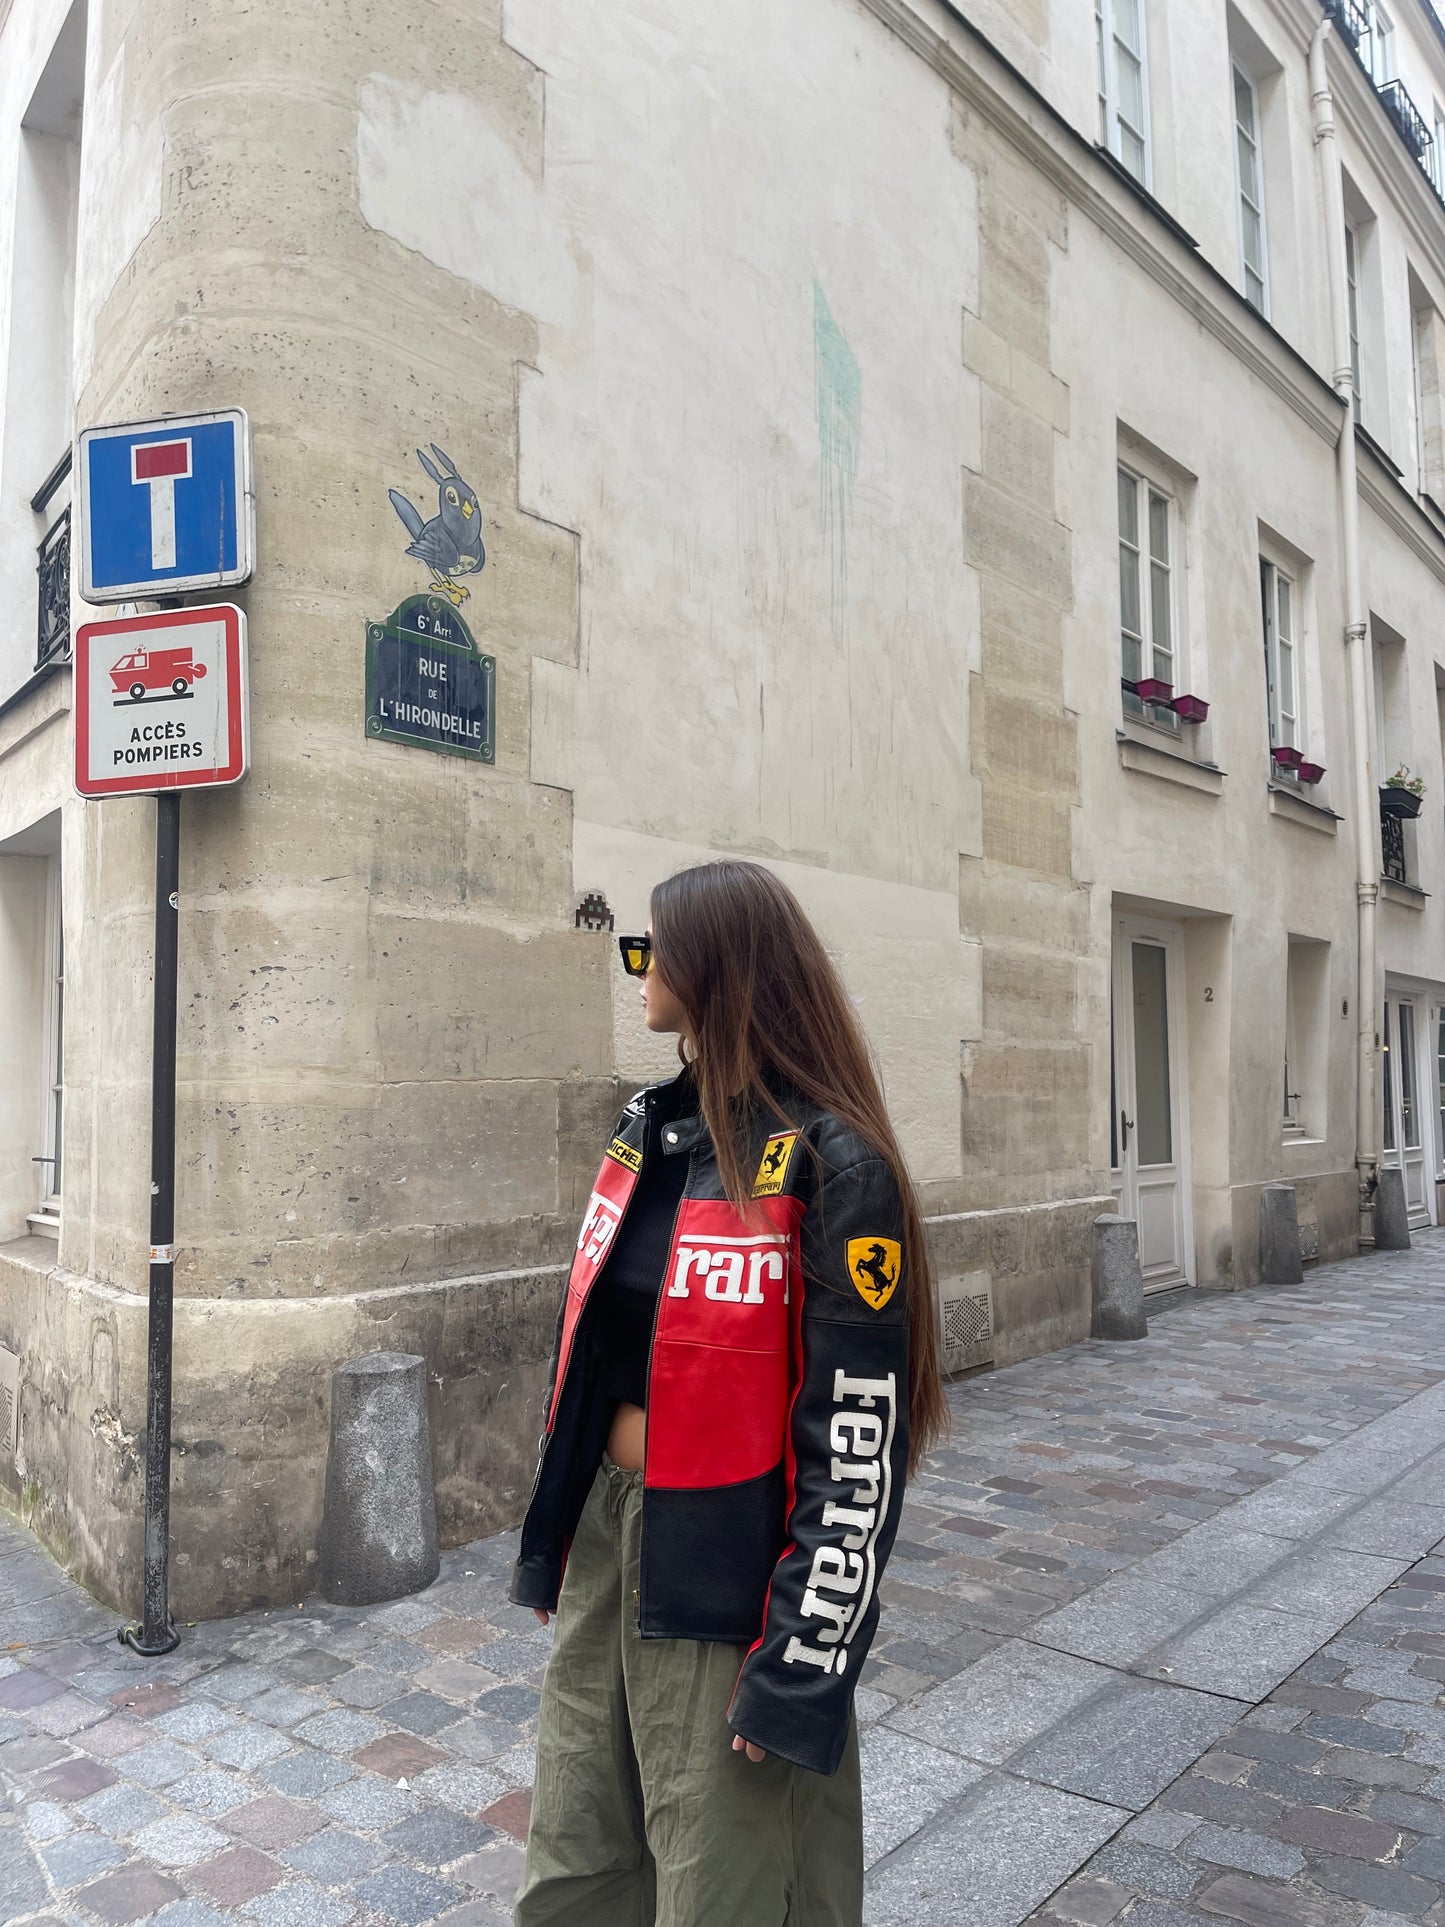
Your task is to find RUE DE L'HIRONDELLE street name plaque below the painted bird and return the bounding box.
[366,595,497,763]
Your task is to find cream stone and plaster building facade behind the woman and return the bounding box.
[0,0,1445,1617]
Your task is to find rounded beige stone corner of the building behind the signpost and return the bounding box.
[0,4,620,1613]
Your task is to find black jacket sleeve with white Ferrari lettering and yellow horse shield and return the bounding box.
[728,1158,907,1773]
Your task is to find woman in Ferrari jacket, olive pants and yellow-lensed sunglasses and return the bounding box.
[512,861,944,1927]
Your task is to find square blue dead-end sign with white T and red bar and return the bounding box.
[79,409,256,603]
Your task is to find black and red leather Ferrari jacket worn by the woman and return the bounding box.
[512,1073,909,1773]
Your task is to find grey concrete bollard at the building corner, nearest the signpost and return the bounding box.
[316,1351,441,1605]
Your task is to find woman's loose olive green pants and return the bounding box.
[514,1459,863,1927]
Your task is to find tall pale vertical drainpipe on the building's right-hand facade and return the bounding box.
[1310,19,1379,1243]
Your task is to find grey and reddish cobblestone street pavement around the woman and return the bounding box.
[0,1237,1445,1927]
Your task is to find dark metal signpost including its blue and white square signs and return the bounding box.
[73,412,254,1655]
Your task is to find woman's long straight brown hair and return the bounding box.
[651,861,948,1472]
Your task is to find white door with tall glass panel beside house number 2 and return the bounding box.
[1110,917,1195,1291]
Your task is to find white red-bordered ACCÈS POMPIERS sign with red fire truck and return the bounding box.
[75,603,250,796]
